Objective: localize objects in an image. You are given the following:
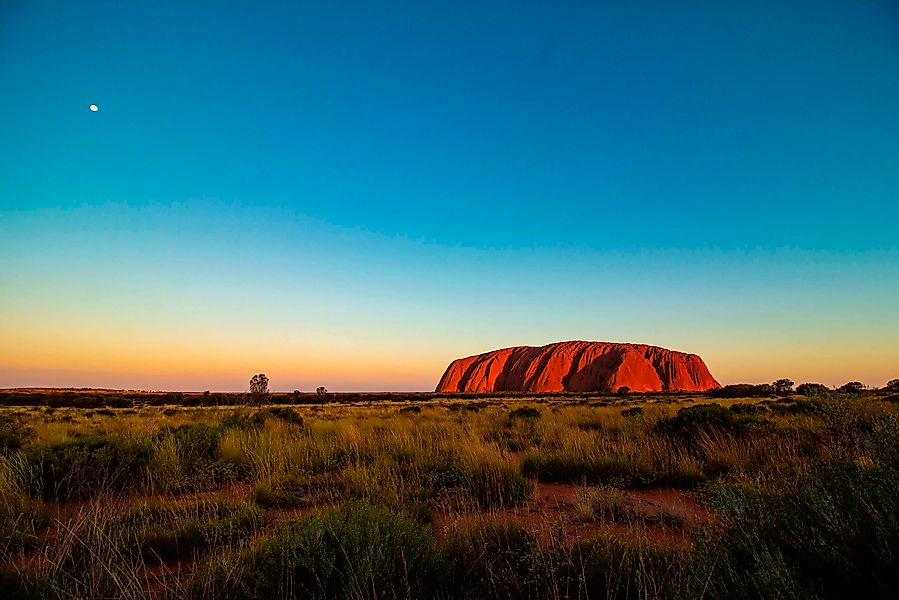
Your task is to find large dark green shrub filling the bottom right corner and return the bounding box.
[694,418,899,598]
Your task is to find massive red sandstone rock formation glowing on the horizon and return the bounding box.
[437,342,721,392]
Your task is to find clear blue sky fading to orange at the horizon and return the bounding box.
[0,0,899,391]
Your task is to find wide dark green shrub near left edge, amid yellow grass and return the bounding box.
[24,436,150,499]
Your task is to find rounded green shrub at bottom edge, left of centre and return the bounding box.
[245,502,449,599]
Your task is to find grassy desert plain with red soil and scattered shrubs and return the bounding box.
[0,386,899,599]
